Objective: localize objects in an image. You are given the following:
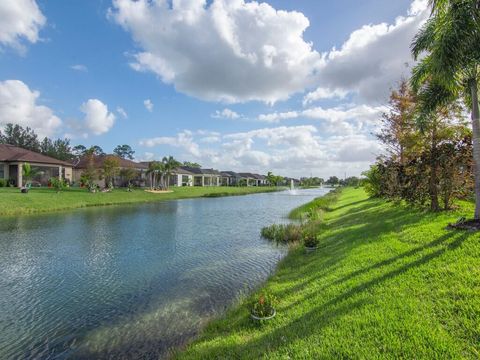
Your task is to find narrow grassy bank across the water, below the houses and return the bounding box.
[0,187,279,215]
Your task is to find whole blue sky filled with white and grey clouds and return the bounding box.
[0,0,429,177]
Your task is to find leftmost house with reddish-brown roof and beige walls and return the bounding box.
[0,144,72,187]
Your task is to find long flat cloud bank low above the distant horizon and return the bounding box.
[140,125,381,176]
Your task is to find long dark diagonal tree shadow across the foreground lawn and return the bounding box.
[182,232,471,359]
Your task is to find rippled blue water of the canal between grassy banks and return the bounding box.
[0,189,326,359]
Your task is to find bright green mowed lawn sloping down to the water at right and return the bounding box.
[178,189,480,359]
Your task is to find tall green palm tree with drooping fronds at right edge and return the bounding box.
[411,0,480,219]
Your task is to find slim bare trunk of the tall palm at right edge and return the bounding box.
[470,79,480,219]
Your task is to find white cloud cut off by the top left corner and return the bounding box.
[0,0,46,51]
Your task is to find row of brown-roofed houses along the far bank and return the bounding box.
[0,144,298,187]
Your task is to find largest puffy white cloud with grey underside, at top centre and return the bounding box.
[109,0,322,103]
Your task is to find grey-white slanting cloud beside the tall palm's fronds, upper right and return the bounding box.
[310,0,429,104]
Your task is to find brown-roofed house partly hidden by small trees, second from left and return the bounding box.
[73,155,148,186]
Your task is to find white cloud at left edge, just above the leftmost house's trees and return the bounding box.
[0,80,62,137]
